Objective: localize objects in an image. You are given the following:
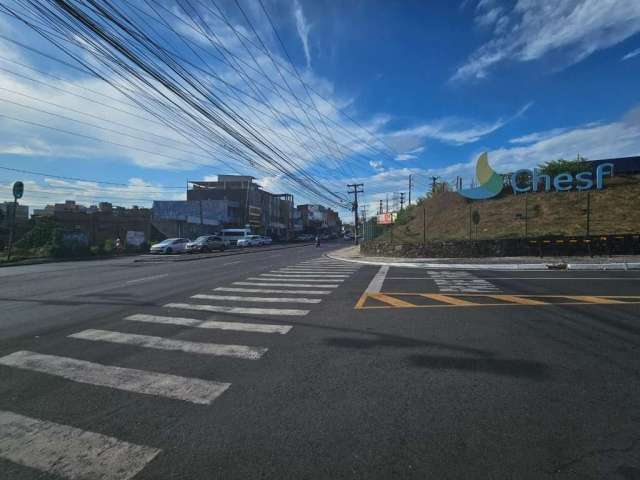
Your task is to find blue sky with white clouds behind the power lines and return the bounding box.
[0,0,640,218]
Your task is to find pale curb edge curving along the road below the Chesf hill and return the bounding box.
[325,253,640,271]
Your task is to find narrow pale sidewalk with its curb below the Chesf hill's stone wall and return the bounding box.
[326,246,640,270]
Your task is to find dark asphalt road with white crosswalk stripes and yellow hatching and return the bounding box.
[0,244,640,480]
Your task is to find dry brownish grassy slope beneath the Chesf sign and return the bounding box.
[379,177,640,243]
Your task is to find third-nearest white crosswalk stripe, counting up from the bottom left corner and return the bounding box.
[69,329,267,360]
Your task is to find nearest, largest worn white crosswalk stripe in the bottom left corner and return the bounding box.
[0,410,161,480]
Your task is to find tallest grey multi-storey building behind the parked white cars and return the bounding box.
[187,175,294,240]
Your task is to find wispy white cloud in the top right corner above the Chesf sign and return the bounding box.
[452,0,640,81]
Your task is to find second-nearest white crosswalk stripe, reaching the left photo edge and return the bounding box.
[0,350,231,405]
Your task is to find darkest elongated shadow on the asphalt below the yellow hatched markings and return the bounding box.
[409,355,550,380]
